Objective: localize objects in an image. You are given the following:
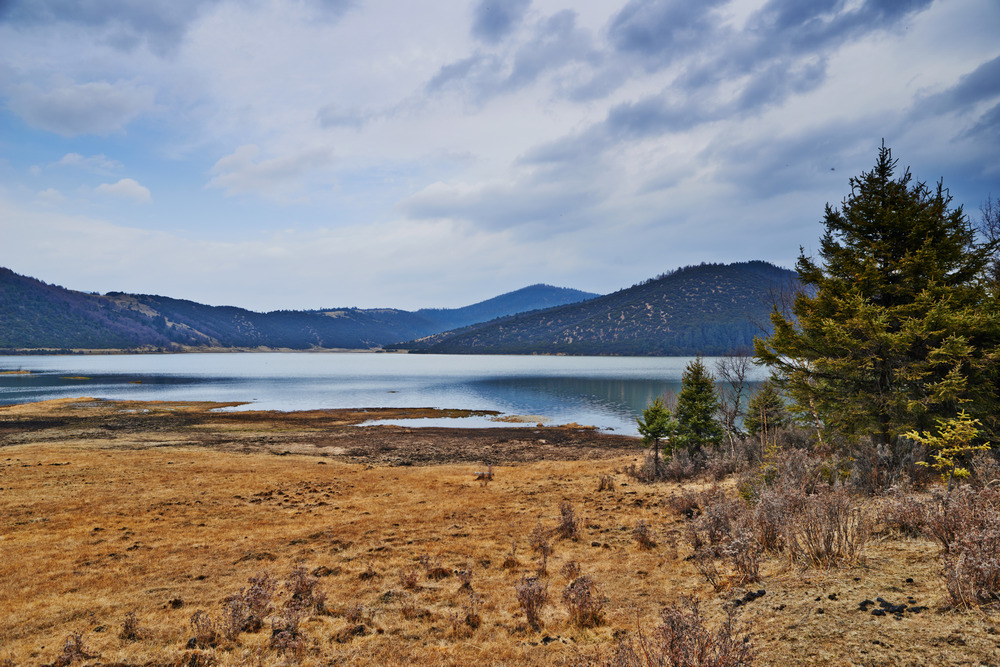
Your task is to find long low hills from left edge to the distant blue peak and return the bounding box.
[0,268,594,350]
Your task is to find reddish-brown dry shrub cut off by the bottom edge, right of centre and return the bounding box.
[603,599,754,667]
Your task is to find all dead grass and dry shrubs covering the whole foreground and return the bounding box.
[0,404,1000,666]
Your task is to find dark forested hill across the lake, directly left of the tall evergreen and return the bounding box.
[389,261,796,355]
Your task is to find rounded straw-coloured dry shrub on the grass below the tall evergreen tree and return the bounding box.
[785,489,872,567]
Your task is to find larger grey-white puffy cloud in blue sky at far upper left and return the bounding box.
[8,80,155,137]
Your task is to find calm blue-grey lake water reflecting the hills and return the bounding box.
[0,353,764,434]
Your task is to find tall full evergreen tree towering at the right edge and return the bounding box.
[755,143,1000,443]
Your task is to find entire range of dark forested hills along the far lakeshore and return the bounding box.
[0,261,795,355]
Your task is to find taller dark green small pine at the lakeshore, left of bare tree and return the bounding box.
[671,357,723,454]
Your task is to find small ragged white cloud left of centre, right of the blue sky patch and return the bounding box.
[207,144,333,199]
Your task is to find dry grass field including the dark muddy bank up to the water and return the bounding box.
[0,399,1000,665]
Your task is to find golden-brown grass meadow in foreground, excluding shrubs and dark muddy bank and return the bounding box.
[0,402,1000,665]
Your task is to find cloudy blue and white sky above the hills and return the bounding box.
[0,0,1000,311]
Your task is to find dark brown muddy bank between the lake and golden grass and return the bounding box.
[0,398,640,466]
